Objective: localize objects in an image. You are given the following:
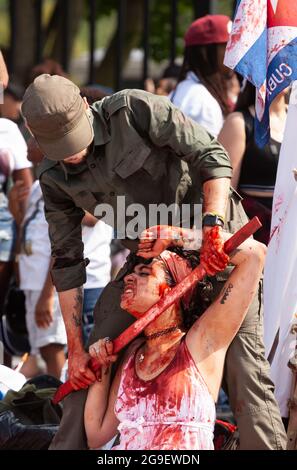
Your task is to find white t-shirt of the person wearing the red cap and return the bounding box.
[169,72,224,137]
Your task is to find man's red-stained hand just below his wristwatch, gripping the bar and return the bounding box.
[200,226,229,276]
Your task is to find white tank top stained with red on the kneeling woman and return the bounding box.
[114,341,215,450]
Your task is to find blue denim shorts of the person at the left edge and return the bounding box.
[0,192,16,263]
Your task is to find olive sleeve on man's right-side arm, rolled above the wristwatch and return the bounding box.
[128,90,232,183]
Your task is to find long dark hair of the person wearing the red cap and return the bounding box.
[178,44,231,116]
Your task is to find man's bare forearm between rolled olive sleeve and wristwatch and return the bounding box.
[203,178,230,216]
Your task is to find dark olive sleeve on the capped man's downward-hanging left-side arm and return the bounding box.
[40,172,86,292]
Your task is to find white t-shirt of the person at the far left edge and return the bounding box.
[0,118,32,185]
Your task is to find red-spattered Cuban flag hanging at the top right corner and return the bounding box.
[225,0,297,147]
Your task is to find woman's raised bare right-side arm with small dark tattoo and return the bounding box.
[186,239,266,399]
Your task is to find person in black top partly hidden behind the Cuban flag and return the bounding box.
[218,81,287,245]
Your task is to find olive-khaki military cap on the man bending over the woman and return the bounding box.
[22,74,94,160]
